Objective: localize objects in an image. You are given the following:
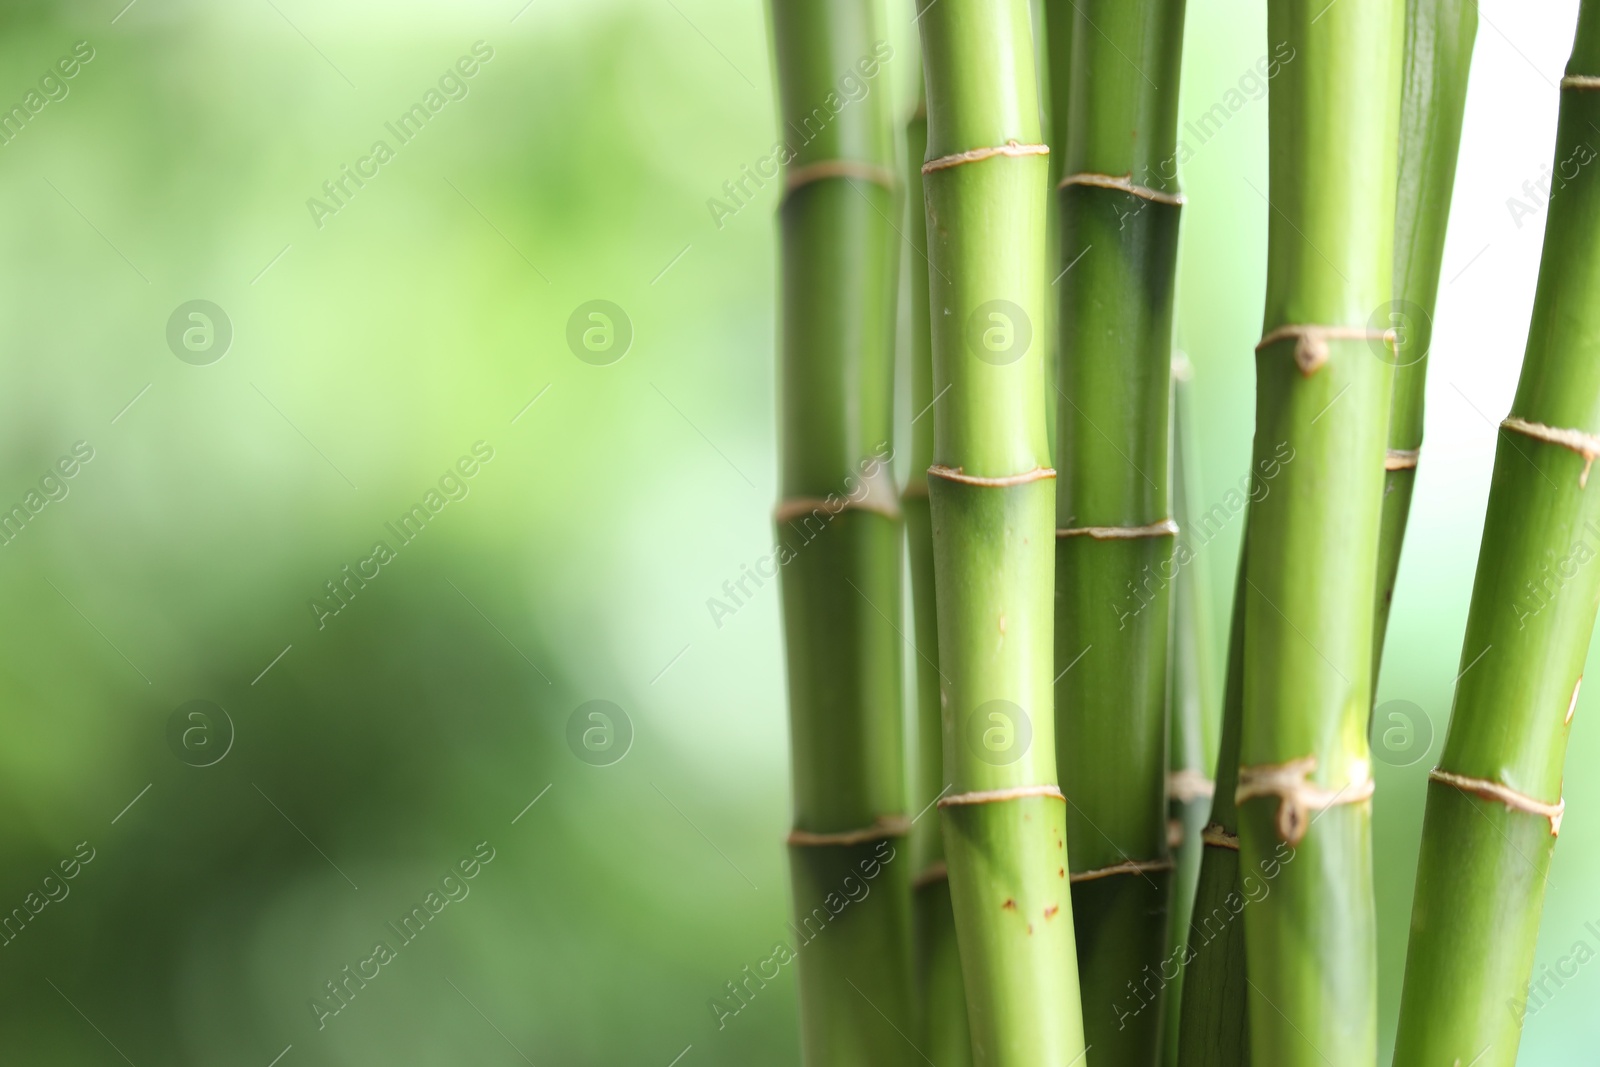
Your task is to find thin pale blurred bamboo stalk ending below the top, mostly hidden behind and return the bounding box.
[1157,354,1221,1067]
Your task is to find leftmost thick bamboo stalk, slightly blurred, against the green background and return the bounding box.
[771,0,920,1067]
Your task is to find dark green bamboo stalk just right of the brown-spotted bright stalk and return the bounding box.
[1051,0,1184,1067]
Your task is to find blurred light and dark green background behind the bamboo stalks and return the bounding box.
[0,0,1600,1067]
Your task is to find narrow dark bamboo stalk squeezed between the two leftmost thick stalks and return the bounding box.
[901,93,973,1067]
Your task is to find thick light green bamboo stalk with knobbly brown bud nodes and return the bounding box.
[1235,0,1405,1067]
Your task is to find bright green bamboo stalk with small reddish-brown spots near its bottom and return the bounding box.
[917,0,1085,1067]
